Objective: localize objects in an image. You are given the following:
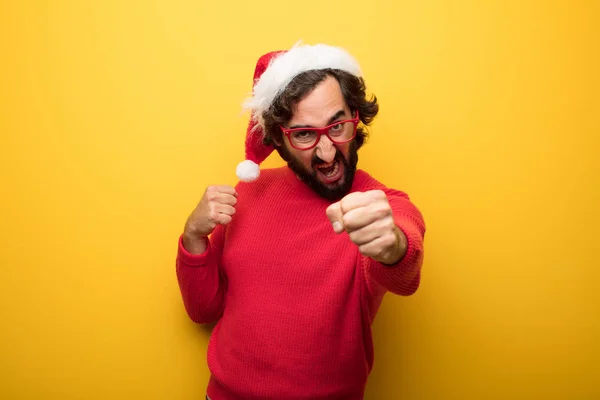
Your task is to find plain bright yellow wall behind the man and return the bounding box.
[0,0,600,399]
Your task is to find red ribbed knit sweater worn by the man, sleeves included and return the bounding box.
[177,167,425,400]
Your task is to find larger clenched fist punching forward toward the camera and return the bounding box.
[327,190,407,264]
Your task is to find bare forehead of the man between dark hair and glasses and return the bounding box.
[289,76,349,126]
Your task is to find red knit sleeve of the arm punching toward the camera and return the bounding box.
[366,188,425,296]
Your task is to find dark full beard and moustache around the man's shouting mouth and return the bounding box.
[277,141,358,201]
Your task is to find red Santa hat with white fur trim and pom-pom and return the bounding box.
[236,44,362,182]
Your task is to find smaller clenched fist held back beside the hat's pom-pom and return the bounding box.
[183,186,237,254]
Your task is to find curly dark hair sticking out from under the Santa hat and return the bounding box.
[262,69,379,154]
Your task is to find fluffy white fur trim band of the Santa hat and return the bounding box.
[243,44,362,126]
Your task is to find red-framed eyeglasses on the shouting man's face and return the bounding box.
[281,111,359,150]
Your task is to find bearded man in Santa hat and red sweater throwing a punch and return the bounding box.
[177,45,425,400]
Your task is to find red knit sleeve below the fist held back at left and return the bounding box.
[176,226,227,324]
